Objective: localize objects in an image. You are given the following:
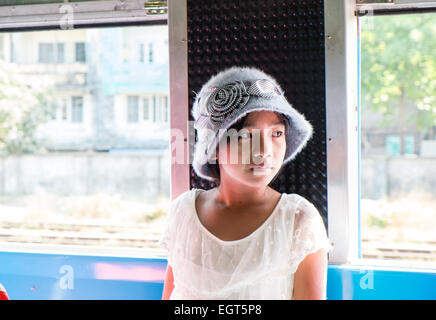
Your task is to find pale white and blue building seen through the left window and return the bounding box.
[0,26,169,150]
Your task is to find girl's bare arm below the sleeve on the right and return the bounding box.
[294,249,327,300]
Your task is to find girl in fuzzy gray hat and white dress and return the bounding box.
[161,67,331,300]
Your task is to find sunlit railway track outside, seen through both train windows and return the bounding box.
[0,221,436,261]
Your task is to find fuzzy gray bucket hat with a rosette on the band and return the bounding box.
[191,67,313,182]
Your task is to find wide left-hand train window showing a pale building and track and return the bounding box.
[0,24,171,253]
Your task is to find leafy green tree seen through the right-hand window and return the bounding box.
[361,14,436,154]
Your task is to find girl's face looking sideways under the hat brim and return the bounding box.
[217,110,286,187]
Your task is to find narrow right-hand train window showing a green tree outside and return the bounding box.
[359,13,436,265]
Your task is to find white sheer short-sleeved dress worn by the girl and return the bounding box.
[161,189,332,300]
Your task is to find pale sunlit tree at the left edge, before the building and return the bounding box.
[0,60,54,155]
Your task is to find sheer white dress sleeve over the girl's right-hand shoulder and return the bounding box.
[290,198,333,273]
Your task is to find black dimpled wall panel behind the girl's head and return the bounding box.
[188,0,327,221]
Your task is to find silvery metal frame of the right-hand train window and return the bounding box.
[324,0,436,268]
